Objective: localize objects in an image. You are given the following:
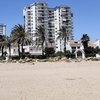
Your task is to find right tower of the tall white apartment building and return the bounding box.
[54,5,73,52]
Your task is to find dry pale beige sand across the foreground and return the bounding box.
[0,61,100,100]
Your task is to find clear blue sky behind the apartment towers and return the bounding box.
[0,0,100,40]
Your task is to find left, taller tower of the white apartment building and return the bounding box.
[23,2,48,40]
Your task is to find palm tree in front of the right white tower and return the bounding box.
[57,26,69,53]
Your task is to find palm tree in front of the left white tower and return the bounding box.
[35,26,46,55]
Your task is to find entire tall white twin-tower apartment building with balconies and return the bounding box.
[23,1,73,52]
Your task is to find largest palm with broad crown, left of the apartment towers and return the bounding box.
[11,24,31,58]
